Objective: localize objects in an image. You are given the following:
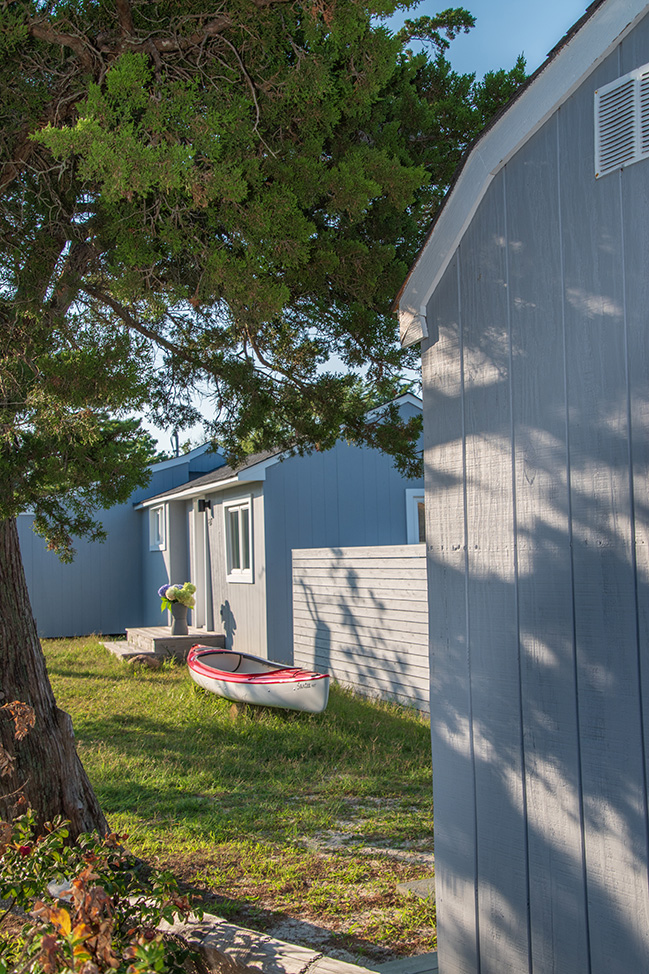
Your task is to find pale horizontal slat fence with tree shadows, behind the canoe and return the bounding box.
[293,544,429,712]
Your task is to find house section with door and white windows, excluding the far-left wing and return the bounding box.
[138,394,424,662]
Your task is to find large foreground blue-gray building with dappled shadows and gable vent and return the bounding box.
[398,0,649,974]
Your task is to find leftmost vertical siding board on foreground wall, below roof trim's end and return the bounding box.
[422,259,479,974]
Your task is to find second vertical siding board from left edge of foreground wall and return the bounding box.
[460,173,529,974]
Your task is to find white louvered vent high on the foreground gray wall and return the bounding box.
[595,64,649,179]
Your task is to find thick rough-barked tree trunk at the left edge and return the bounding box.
[0,520,107,838]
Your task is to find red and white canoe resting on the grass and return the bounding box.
[187,646,329,714]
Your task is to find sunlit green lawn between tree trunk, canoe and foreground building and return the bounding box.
[44,638,435,963]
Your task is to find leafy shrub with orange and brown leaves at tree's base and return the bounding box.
[0,811,200,974]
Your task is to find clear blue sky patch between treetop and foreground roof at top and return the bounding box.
[388,0,588,78]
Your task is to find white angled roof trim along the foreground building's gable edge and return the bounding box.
[398,0,649,346]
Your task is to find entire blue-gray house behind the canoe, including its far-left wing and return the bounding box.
[18,394,424,661]
